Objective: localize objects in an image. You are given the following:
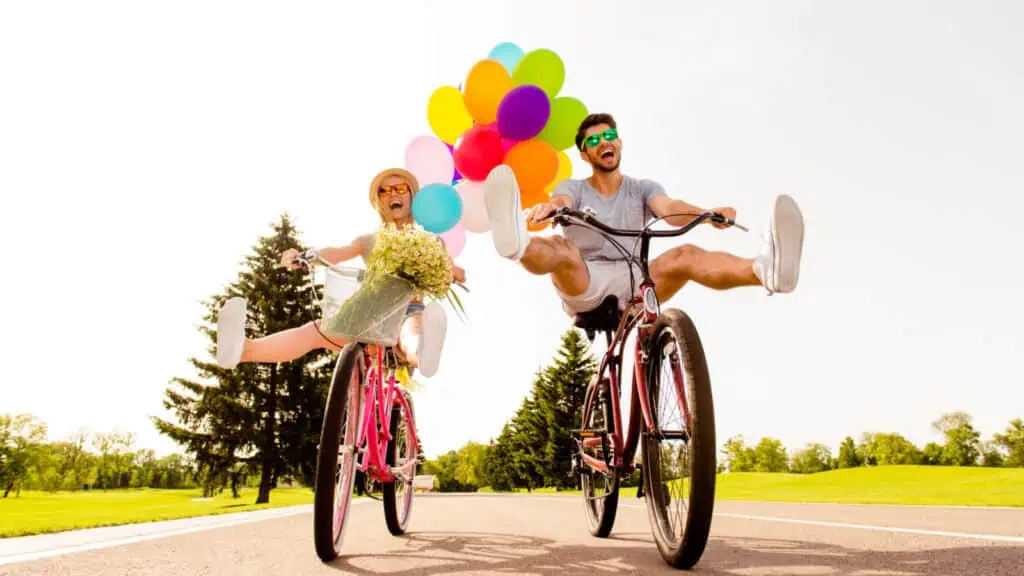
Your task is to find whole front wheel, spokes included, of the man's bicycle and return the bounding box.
[641,310,717,570]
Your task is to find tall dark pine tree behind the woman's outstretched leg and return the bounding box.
[154,214,332,503]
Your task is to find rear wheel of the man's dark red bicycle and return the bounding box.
[579,376,620,538]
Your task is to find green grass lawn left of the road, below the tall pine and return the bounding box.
[0,488,313,538]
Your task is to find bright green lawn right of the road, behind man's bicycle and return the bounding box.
[481,466,1024,506]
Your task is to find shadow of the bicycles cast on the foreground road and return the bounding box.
[331,532,1024,576]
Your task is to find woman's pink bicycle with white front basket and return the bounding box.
[297,251,419,562]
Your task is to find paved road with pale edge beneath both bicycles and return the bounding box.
[0,495,1024,576]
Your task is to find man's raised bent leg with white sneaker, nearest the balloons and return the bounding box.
[483,165,590,296]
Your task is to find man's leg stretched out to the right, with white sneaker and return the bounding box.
[650,195,804,301]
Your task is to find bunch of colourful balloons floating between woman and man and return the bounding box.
[406,42,587,257]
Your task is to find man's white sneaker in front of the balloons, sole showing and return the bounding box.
[483,164,529,261]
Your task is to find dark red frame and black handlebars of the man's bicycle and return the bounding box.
[554,209,716,474]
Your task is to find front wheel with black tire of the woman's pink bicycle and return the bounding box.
[313,343,362,563]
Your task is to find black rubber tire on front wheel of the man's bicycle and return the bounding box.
[642,308,717,570]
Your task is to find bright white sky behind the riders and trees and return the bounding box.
[0,1,1024,456]
